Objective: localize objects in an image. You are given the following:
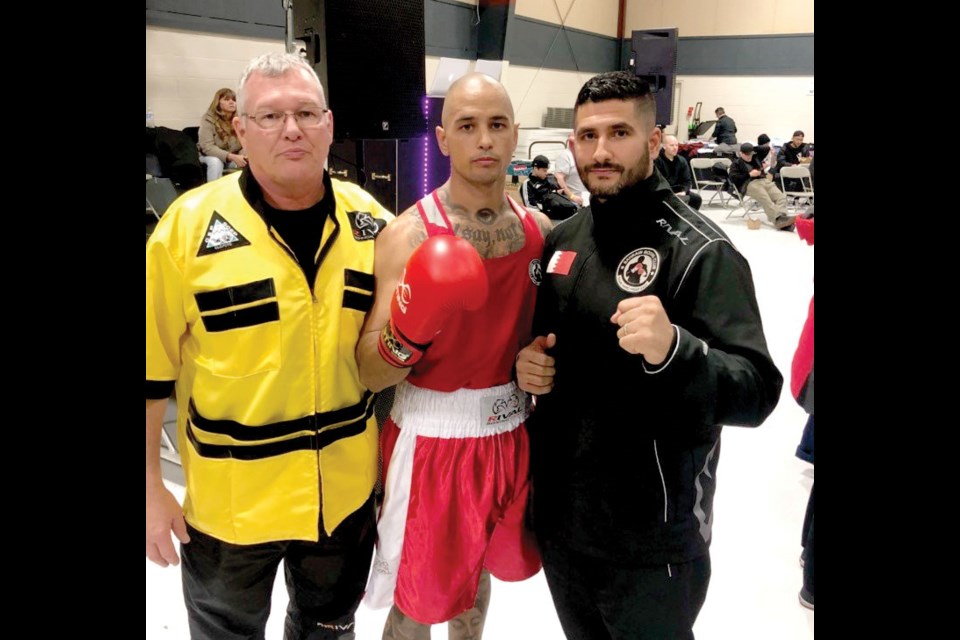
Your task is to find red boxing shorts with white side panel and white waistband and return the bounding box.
[364,382,540,624]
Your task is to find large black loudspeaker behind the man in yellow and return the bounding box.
[293,0,426,139]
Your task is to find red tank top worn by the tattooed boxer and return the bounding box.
[407,191,543,391]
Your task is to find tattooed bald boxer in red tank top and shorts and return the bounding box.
[357,74,551,640]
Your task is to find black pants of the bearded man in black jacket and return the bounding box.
[540,542,710,640]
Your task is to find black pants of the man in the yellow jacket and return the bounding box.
[180,496,377,640]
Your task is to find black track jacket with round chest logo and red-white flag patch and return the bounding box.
[527,172,783,564]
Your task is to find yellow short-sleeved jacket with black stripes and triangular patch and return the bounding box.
[146,169,393,544]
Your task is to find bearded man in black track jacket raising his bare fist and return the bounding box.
[516,71,783,640]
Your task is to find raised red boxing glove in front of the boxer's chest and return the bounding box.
[377,235,488,367]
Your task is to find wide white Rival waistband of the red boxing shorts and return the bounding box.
[390,380,530,438]
